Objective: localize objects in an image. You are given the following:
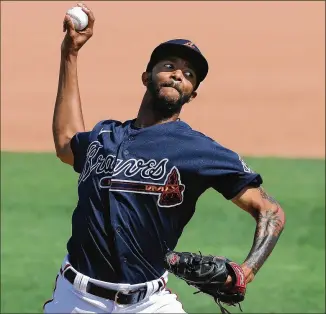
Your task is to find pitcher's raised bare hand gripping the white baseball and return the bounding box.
[61,3,95,55]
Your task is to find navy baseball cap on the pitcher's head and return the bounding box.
[146,39,208,89]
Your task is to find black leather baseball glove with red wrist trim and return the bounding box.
[164,251,246,314]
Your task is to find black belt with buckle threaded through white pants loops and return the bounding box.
[63,268,163,305]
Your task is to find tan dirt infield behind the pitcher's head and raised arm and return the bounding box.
[1,1,325,157]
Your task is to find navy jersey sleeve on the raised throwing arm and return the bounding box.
[70,132,91,173]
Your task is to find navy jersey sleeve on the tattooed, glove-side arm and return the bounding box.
[201,141,263,200]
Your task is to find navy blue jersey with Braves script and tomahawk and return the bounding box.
[67,120,262,284]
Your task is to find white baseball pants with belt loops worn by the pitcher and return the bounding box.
[43,257,186,313]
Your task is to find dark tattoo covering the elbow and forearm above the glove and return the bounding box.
[244,188,285,274]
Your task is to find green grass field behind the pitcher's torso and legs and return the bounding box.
[1,153,325,313]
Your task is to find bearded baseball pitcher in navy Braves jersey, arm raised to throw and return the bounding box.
[44,4,285,313]
